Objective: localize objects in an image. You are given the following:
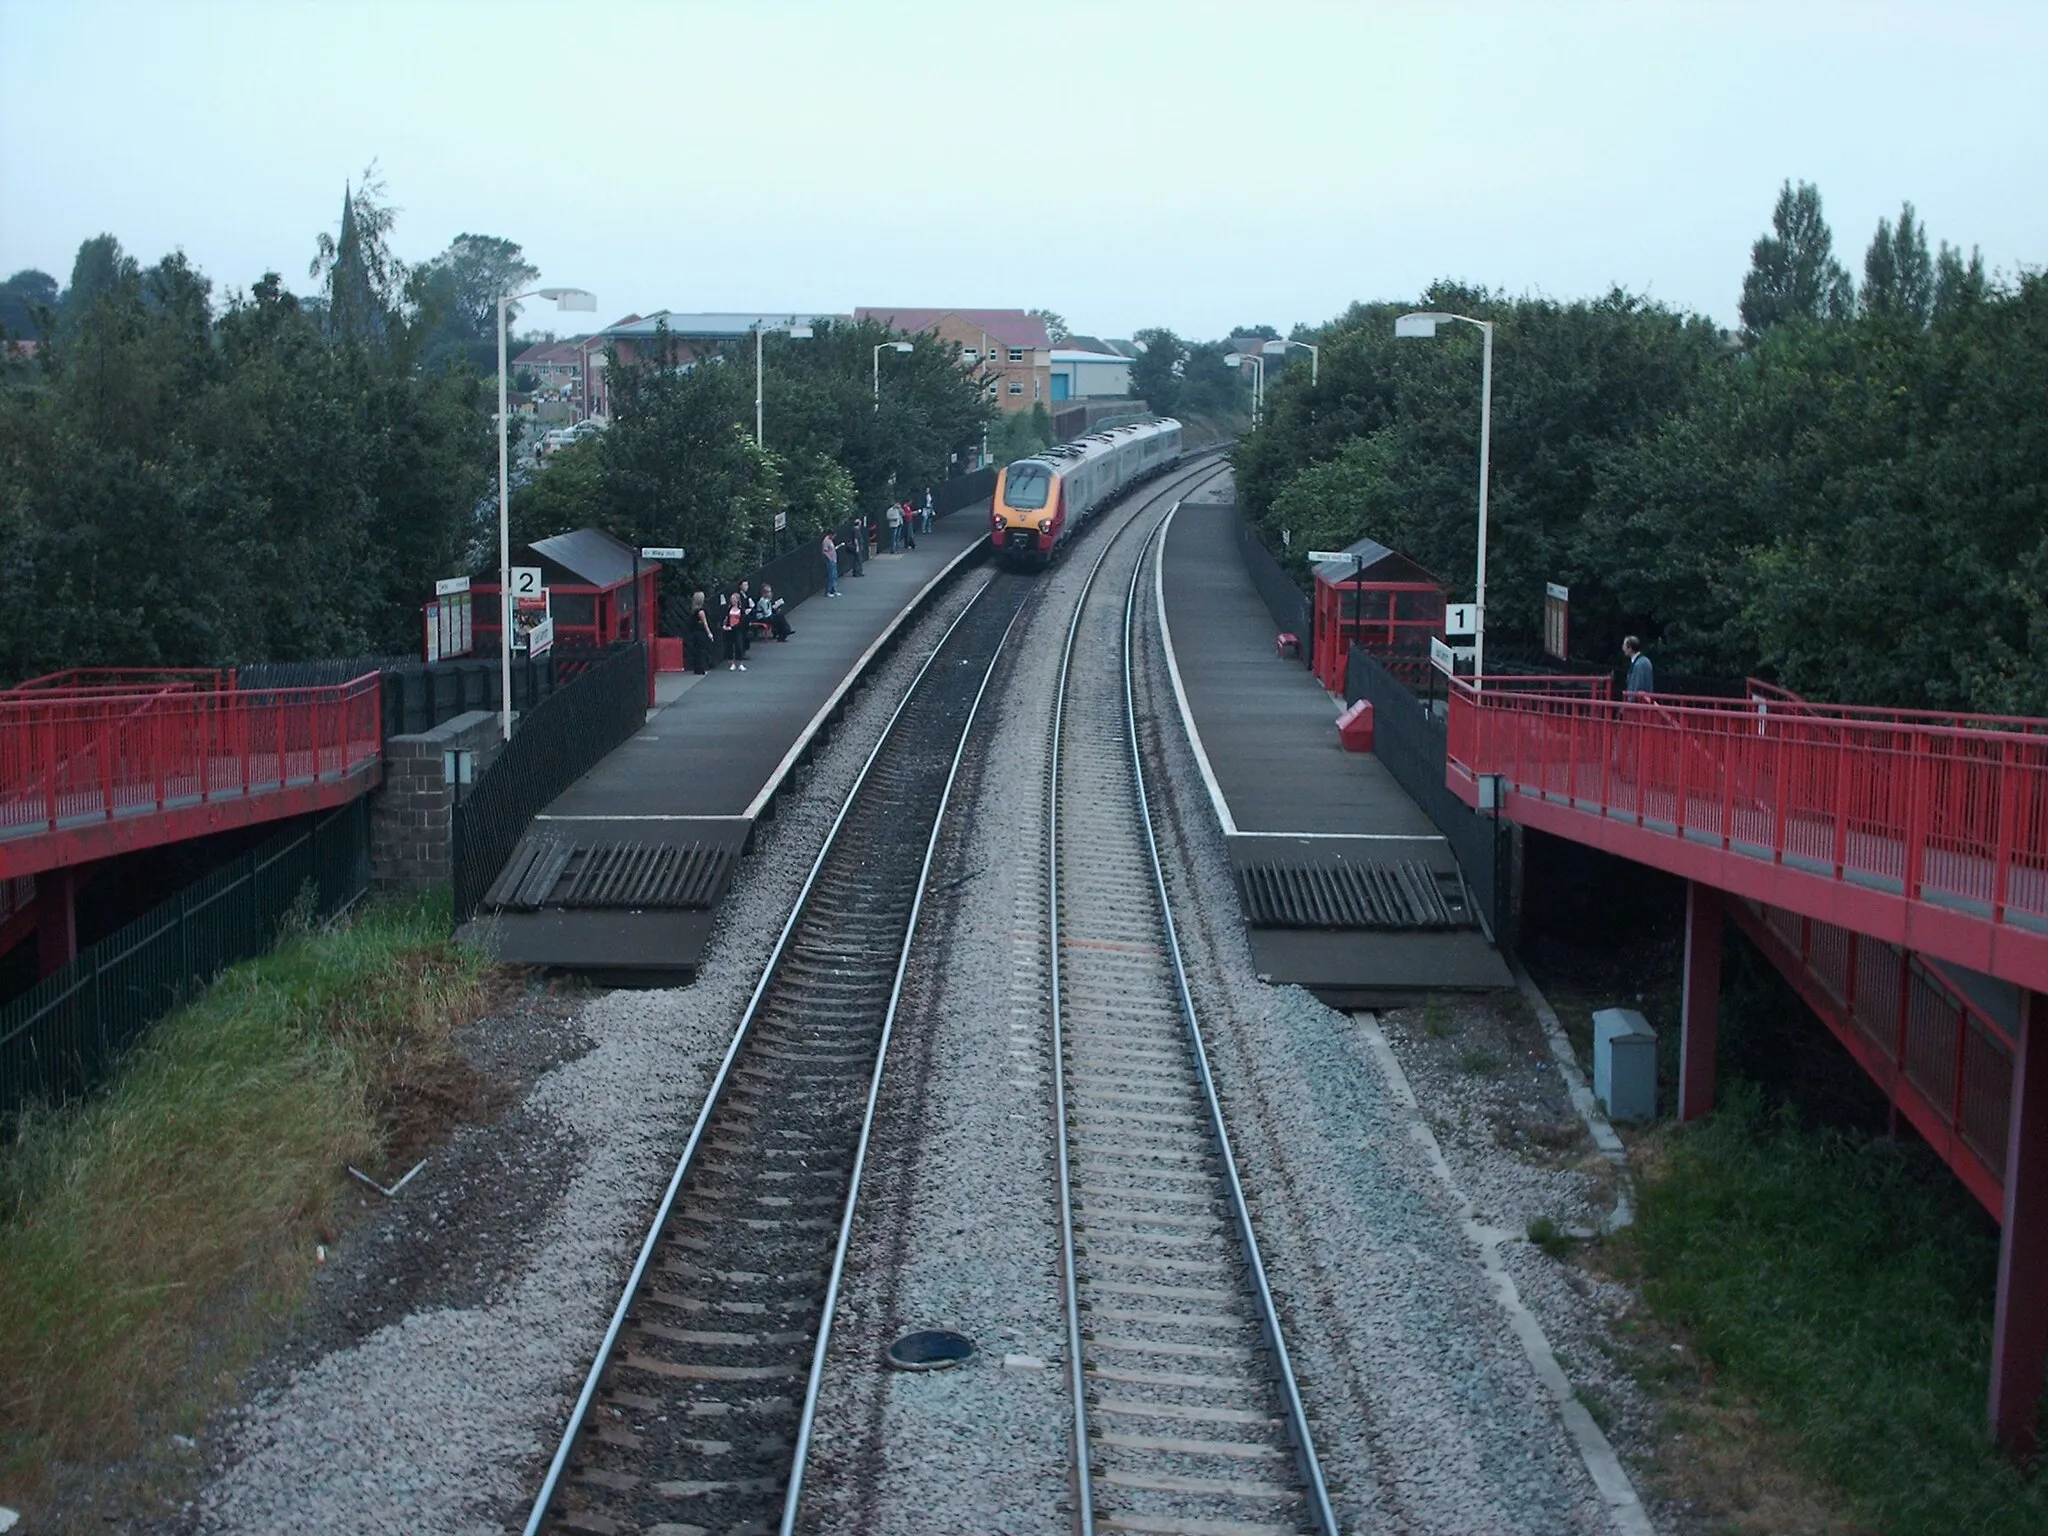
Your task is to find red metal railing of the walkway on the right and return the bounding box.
[1448,678,2048,985]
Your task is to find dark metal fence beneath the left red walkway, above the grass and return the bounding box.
[0,797,371,1126]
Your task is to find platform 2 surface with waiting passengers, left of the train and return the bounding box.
[473,512,989,985]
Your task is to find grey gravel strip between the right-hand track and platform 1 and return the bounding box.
[1141,499,1638,1536]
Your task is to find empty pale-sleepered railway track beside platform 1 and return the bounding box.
[1047,499,1337,1536]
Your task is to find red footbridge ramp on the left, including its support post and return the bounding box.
[0,670,383,975]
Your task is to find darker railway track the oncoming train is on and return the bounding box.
[526,575,1032,1536]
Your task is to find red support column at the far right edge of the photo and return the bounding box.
[1991,991,2048,1456]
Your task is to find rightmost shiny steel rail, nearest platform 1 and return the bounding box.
[1124,502,1339,1536]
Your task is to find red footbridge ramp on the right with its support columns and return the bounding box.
[1446,678,2048,1454]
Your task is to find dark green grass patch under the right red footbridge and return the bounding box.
[1634,1083,2048,1536]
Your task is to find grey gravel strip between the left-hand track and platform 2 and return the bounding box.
[195,578,977,1536]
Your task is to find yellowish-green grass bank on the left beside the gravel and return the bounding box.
[0,899,481,1497]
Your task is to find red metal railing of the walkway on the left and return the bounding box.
[0,672,383,838]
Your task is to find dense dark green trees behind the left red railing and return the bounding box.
[0,236,494,676]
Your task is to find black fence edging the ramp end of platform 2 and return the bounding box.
[449,641,647,922]
